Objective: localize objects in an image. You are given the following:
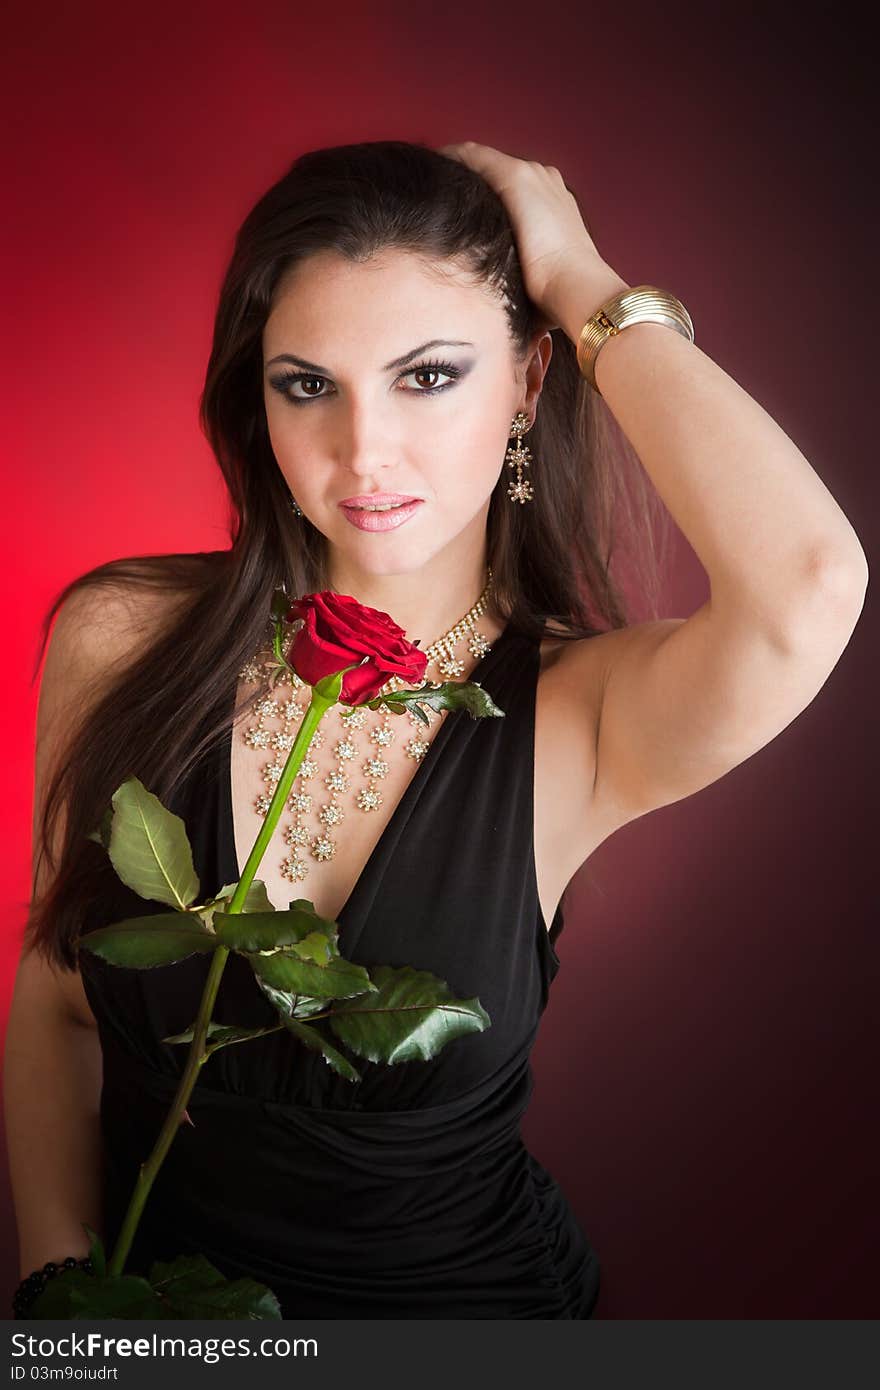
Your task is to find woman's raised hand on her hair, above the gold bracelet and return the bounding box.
[438,140,628,328]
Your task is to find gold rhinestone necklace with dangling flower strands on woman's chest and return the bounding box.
[239,567,494,883]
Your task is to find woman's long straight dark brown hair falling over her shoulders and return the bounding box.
[25,140,666,969]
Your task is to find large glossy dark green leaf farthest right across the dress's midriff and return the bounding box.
[328,965,491,1066]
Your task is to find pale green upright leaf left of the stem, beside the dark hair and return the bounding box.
[108,777,199,912]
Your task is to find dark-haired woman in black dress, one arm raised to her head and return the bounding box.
[7,142,866,1318]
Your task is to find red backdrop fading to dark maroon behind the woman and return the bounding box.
[0,0,879,1319]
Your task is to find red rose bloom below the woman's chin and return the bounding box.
[286,589,428,705]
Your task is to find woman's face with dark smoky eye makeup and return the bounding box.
[263,250,552,574]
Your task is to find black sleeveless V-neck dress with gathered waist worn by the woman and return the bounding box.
[79,626,599,1319]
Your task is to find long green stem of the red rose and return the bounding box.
[107,667,348,1275]
